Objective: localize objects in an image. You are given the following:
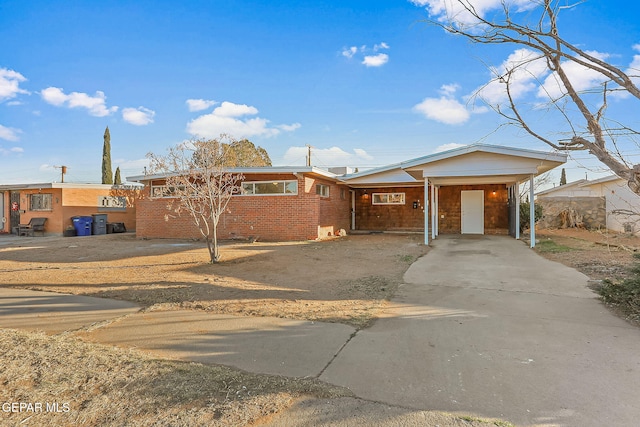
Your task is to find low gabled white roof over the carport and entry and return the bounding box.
[344,144,567,185]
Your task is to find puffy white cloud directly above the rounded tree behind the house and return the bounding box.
[187,101,300,138]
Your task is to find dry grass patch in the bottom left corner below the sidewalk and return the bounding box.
[0,329,351,426]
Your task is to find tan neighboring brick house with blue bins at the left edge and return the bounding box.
[0,183,136,235]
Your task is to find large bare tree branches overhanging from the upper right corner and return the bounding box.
[412,0,640,194]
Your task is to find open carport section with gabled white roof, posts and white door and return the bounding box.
[344,144,567,247]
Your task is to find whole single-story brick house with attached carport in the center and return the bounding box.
[127,144,566,247]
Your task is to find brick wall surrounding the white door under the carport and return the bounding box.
[438,184,509,234]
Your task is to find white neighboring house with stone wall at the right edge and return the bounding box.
[536,175,640,233]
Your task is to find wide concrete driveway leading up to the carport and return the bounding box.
[320,236,640,426]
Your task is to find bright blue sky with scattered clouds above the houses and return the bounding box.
[0,0,640,184]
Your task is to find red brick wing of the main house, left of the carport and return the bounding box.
[127,167,349,241]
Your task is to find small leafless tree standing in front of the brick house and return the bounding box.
[147,135,243,262]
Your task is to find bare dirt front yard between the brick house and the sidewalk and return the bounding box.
[0,234,426,327]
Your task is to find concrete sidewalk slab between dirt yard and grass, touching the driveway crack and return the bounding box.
[79,310,355,377]
